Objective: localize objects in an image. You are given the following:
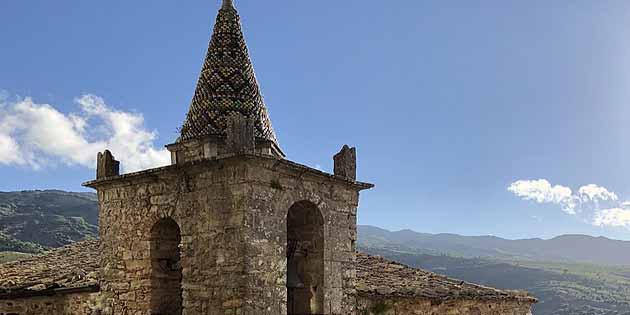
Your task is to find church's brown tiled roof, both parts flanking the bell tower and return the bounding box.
[0,241,536,302]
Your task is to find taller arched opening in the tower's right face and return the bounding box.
[287,201,324,315]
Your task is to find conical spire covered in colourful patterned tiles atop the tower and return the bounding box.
[178,0,278,146]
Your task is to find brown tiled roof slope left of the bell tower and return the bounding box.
[0,241,99,298]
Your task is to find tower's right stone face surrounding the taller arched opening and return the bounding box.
[240,159,359,315]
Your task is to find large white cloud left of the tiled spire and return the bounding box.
[0,94,170,172]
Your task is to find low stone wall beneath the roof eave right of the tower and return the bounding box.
[357,296,532,315]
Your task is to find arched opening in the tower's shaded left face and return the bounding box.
[150,219,182,315]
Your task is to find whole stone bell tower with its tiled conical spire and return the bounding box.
[85,0,372,315]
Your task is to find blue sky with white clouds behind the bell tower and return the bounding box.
[0,0,630,239]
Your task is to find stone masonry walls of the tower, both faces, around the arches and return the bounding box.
[91,156,358,315]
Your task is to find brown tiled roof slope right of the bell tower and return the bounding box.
[357,253,536,302]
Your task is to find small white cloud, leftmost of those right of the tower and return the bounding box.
[508,179,575,214]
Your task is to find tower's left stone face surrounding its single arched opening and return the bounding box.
[98,162,247,315]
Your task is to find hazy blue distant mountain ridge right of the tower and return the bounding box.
[358,225,630,265]
